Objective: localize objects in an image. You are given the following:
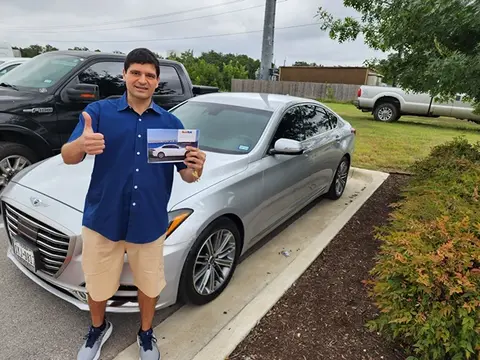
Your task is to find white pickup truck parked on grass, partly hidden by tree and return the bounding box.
[354,85,480,124]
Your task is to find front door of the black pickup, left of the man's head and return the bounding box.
[56,59,125,143]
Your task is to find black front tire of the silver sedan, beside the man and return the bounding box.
[179,217,242,305]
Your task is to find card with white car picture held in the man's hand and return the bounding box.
[147,129,199,164]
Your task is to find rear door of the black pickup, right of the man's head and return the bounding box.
[153,64,189,110]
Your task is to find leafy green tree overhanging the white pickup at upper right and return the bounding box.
[317,0,480,113]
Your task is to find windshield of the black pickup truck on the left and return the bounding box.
[2,53,82,90]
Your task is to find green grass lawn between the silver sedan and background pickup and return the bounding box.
[324,102,480,172]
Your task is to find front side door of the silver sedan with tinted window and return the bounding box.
[250,105,315,237]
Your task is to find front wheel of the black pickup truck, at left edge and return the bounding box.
[0,141,39,191]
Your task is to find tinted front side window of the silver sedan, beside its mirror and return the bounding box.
[272,105,319,146]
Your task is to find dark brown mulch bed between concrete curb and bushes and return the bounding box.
[228,174,408,360]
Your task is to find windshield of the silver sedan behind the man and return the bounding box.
[172,101,272,154]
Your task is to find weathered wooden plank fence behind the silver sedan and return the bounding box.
[232,79,360,102]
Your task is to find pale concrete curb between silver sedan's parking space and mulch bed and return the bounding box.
[192,168,389,360]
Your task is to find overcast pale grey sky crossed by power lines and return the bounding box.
[0,0,383,66]
